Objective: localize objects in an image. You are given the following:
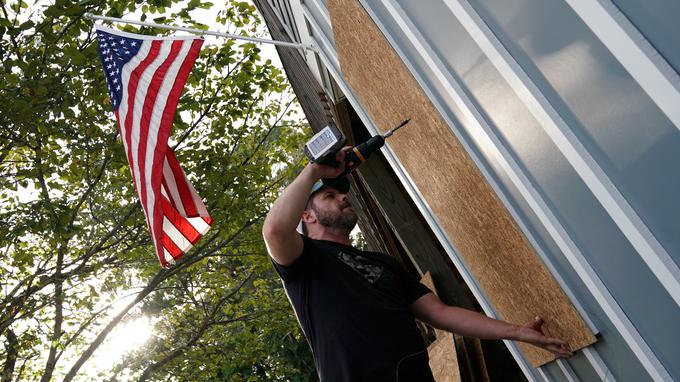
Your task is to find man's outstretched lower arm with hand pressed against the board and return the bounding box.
[411,293,571,357]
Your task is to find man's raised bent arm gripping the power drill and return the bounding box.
[262,148,347,266]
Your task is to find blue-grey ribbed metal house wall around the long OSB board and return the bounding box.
[262,0,680,381]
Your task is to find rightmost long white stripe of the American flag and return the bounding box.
[144,41,191,252]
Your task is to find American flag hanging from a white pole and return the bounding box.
[96,26,212,267]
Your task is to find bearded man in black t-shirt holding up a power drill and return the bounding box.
[263,148,570,382]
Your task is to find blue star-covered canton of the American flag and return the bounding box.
[97,30,143,110]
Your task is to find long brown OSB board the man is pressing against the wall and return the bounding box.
[328,0,595,366]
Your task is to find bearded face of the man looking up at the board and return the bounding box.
[310,187,358,231]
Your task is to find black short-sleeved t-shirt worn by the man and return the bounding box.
[274,236,434,382]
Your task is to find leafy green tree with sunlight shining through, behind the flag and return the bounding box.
[0,0,314,382]
